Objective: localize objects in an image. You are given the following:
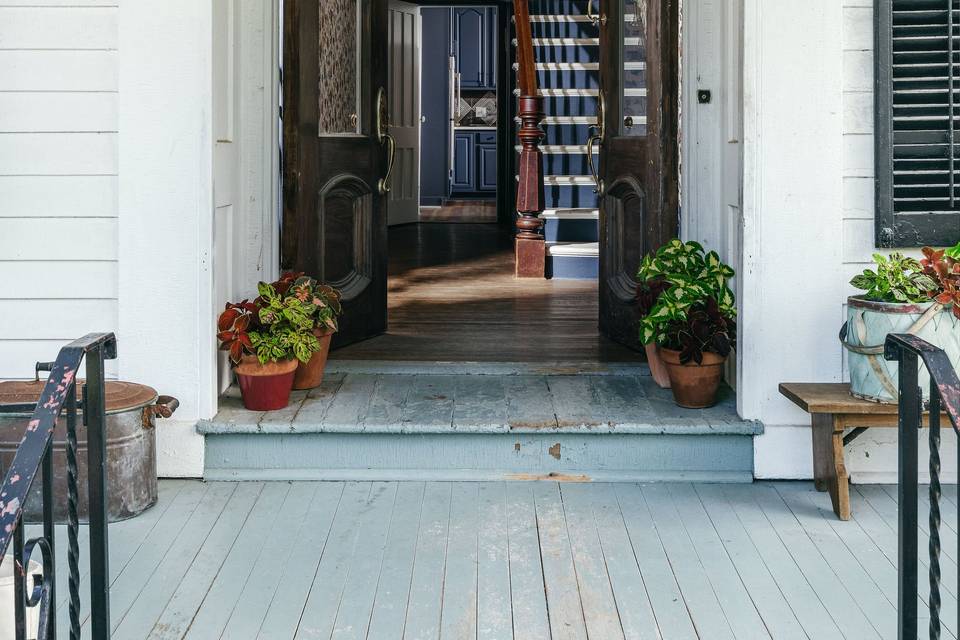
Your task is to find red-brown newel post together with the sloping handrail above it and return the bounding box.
[513,0,547,278]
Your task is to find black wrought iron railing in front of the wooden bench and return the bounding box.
[884,334,960,640]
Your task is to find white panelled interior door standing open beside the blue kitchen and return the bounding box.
[387,0,422,225]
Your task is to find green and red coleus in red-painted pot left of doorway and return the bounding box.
[217,282,320,411]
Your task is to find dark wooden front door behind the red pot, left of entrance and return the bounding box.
[281,0,394,346]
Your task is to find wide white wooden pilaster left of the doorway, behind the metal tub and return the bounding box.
[118,0,217,476]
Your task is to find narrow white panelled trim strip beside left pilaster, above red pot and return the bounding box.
[212,0,243,393]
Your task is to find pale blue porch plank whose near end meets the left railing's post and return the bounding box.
[110,483,236,638]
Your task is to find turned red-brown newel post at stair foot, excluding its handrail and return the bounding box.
[517,96,546,278]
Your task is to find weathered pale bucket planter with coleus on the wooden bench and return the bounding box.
[840,244,960,403]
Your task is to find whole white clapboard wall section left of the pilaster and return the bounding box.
[0,0,118,378]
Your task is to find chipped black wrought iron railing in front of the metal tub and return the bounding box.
[0,333,117,640]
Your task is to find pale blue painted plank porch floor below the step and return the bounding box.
[57,480,957,640]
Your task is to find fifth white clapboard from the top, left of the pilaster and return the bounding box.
[0,176,118,218]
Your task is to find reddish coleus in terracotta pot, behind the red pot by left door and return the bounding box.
[273,273,341,389]
